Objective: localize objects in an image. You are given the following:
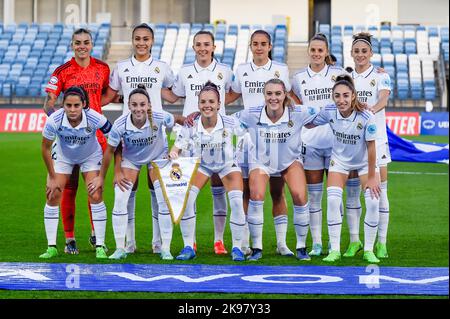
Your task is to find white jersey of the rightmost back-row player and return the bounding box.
[352,65,391,145]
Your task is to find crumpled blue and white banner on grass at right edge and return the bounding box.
[386,126,449,164]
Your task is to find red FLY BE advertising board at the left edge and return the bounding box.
[0,109,47,132]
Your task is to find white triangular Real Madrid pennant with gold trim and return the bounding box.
[151,157,200,224]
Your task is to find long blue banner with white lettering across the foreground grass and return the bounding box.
[0,263,449,296]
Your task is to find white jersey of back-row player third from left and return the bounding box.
[172,60,233,116]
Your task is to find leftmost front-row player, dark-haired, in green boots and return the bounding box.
[39,86,111,259]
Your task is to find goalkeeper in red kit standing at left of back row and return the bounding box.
[44,28,110,254]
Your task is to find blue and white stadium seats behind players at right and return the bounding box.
[318,24,449,105]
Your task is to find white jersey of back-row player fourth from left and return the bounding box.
[231,59,291,108]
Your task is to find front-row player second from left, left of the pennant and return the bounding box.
[89,84,184,259]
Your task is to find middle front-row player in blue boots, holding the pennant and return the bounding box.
[169,81,245,261]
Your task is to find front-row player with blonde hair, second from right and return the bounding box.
[236,79,310,261]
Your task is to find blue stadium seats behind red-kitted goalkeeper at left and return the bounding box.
[0,23,111,97]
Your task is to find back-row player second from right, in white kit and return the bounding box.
[292,33,345,256]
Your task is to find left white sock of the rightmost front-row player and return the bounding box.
[327,186,343,252]
